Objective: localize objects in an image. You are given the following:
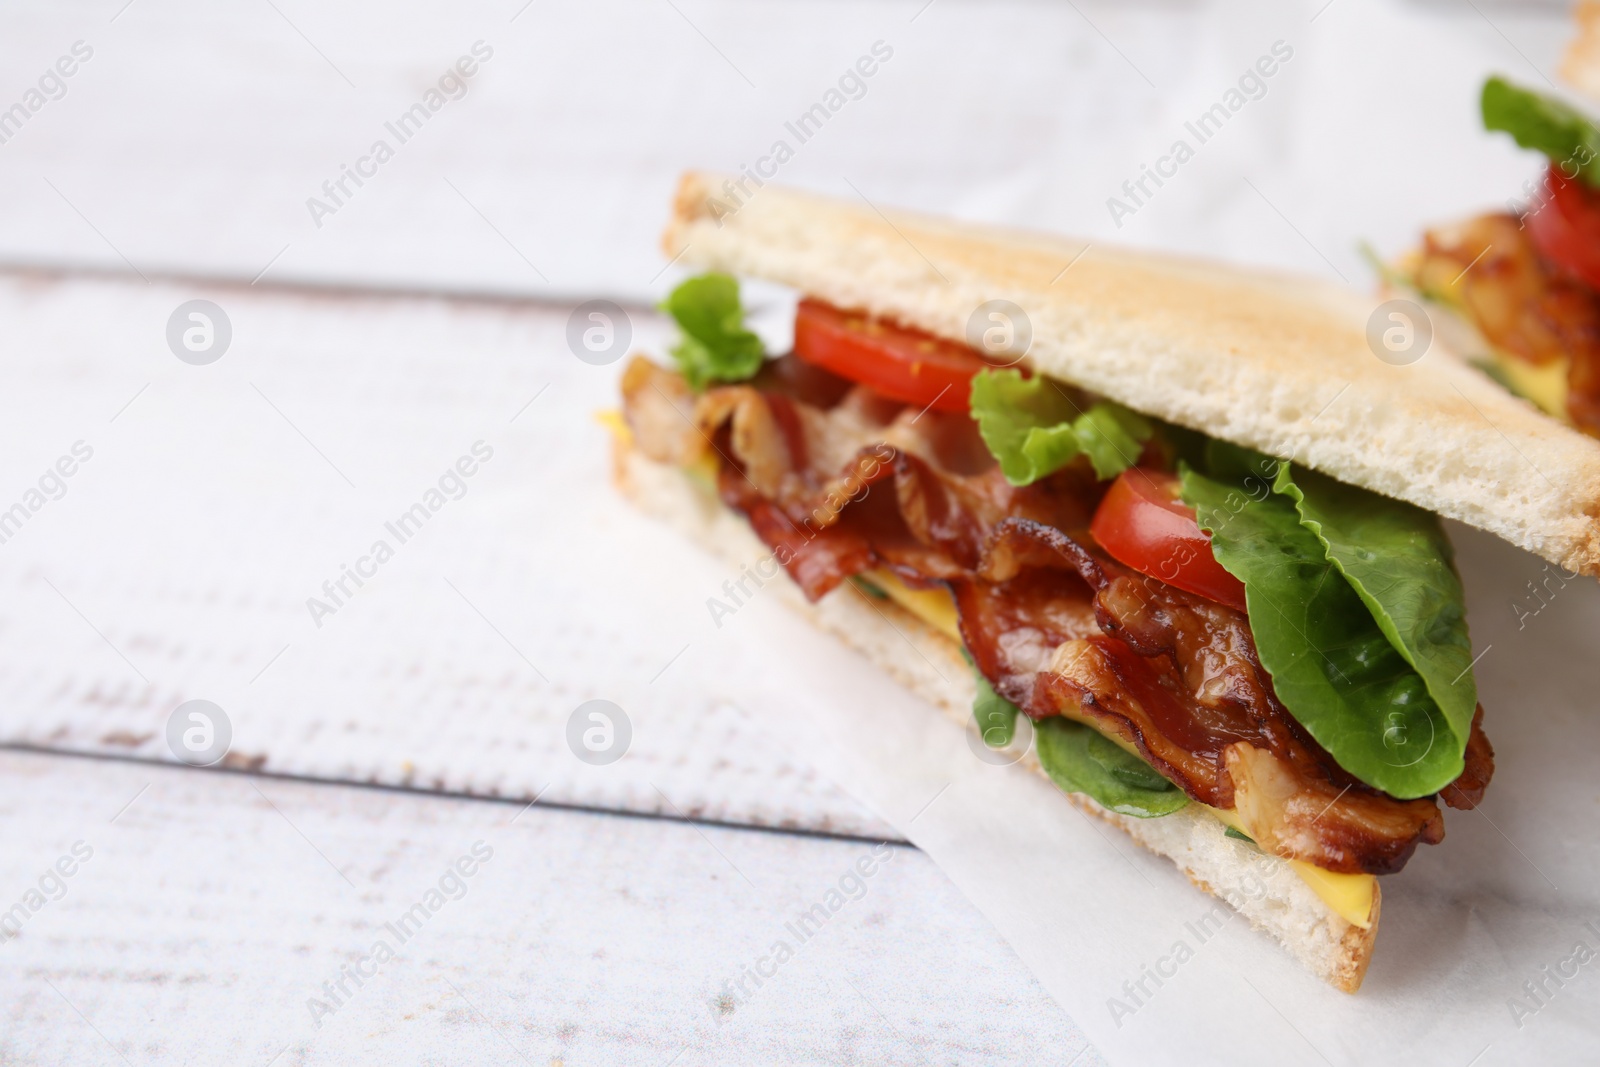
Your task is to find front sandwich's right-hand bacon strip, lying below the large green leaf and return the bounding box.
[987,520,1445,873]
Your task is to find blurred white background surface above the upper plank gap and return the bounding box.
[0,0,1571,301]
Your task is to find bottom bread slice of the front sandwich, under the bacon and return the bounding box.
[613,440,1381,993]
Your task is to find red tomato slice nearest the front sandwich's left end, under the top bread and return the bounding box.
[795,299,989,411]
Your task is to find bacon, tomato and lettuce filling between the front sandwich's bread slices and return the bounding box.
[622,275,1493,895]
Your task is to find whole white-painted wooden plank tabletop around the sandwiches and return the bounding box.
[0,0,1587,1067]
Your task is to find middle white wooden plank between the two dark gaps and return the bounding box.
[0,275,896,837]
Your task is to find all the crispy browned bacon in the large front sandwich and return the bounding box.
[624,362,1493,873]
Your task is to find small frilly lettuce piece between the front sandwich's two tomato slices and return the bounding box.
[971,370,1154,485]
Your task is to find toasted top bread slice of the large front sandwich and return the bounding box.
[662,173,1600,576]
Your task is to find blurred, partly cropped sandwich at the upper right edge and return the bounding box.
[1401,77,1600,435]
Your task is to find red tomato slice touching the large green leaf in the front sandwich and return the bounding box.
[1090,467,1245,611]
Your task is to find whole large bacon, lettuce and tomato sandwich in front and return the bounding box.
[610,173,1600,992]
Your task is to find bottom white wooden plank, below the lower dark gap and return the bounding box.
[0,752,1099,1067]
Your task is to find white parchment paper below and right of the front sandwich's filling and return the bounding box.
[704,502,1600,1065]
